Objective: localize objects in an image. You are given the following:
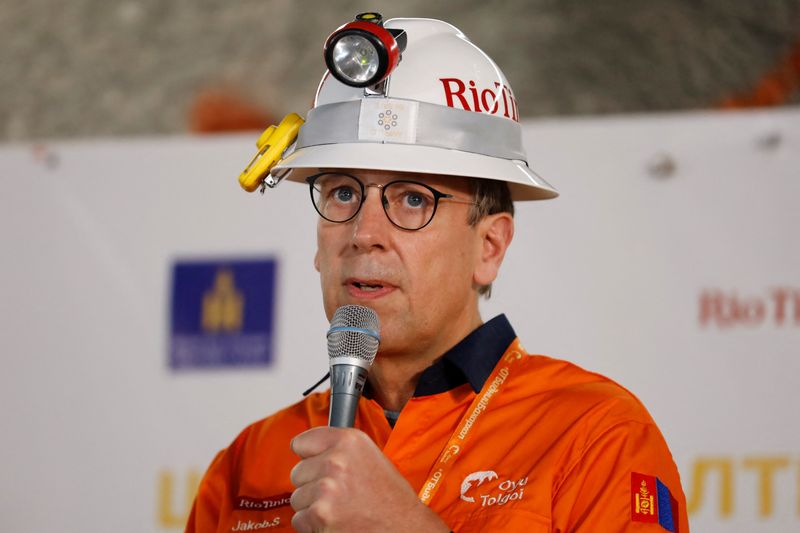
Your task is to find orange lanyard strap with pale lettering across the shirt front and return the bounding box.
[419,339,522,505]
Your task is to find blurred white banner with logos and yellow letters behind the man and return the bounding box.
[0,108,800,533]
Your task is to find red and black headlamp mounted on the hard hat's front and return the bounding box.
[323,13,406,87]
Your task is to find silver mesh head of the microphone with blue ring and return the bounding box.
[328,305,381,369]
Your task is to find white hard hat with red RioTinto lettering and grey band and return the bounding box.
[272,18,558,200]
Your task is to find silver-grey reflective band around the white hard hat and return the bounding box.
[296,98,527,161]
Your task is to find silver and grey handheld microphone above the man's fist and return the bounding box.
[327,305,381,428]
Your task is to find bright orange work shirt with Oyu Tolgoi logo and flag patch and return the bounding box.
[186,317,689,533]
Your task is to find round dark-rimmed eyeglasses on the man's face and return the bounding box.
[306,172,475,231]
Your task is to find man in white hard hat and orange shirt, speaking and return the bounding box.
[187,14,688,533]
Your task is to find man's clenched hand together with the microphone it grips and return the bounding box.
[291,305,450,533]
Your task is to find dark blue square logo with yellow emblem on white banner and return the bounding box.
[170,259,277,369]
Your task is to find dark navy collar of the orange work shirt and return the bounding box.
[414,315,517,396]
